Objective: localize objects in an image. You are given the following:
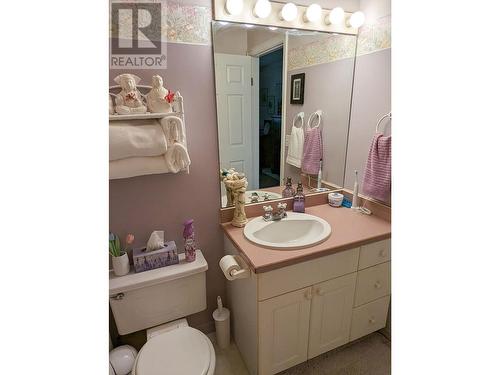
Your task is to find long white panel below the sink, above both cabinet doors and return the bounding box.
[257,247,359,301]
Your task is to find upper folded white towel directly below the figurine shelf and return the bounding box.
[109,120,167,160]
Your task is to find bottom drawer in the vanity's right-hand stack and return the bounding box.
[350,296,390,341]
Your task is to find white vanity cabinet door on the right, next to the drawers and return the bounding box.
[308,273,356,358]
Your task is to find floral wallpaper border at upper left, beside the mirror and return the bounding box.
[109,0,212,45]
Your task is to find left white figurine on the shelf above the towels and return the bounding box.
[114,74,147,115]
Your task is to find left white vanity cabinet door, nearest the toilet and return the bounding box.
[259,287,312,374]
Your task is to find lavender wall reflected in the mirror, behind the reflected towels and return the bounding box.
[285,58,354,186]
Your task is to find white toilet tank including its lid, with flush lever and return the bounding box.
[109,250,208,335]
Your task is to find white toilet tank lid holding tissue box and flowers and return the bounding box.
[109,250,208,296]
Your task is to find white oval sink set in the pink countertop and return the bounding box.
[243,212,332,250]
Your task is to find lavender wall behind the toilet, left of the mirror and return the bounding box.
[109,43,225,330]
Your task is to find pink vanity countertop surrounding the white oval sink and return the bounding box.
[221,204,391,273]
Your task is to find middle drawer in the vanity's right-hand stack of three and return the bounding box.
[354,262,391,306]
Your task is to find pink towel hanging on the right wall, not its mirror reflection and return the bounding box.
[363,133,391,202]
